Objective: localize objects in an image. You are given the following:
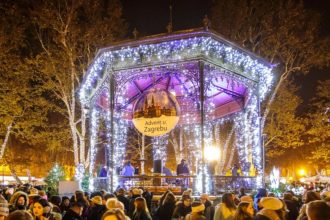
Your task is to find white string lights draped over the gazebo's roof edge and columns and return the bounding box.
[80,30,272,192]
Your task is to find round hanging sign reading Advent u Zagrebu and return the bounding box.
[133,89,180,137]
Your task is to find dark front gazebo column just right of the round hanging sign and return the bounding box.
[199,61,206,193]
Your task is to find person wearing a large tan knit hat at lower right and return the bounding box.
[255,197,285,220]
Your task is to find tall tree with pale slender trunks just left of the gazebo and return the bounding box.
[30,0,125,167]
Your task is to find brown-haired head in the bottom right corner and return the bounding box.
[306,200,330,220]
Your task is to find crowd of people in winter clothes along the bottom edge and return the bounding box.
[0,185,330,220]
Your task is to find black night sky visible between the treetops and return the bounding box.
[122,0,330,104]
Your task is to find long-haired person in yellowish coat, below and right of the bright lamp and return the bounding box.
[213,193,236,220]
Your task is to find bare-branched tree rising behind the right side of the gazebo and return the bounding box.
[212,0,330,128]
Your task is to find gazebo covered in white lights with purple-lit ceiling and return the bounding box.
[80,28,272,192]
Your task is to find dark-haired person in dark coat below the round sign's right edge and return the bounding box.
[156,191,176,220]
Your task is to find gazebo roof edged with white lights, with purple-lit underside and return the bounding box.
[80,29,272,118]
